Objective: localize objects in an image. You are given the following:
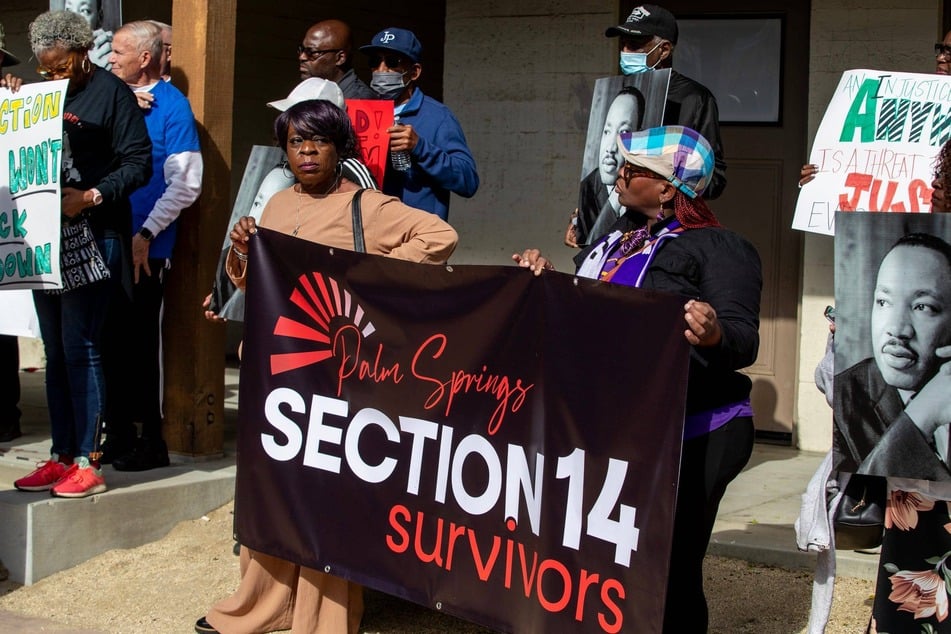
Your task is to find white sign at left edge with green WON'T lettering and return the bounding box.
[0,80,68,288]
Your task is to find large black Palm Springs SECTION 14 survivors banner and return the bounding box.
[235,229,689,632]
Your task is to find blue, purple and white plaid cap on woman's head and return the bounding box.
[618,125,713,198]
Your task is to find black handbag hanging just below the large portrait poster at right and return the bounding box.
[832,473,886,550]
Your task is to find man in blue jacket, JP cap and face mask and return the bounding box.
[360,28,479,220]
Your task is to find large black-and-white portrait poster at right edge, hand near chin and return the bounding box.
[833,212,951,480]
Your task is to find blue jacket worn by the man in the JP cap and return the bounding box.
[383,88,479,220]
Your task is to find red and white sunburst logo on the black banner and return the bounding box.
[271,273,376,375]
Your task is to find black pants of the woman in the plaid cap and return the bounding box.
[664,416,753,634]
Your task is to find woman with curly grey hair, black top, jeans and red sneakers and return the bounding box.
[14,11,152,497]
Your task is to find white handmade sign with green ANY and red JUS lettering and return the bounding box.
[793,70,951,235]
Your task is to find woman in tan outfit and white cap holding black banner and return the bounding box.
[195,100,458,634]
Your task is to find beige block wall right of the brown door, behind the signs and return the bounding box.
[797,0,942,451]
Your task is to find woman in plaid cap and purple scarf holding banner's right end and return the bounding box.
[512,126,762,633]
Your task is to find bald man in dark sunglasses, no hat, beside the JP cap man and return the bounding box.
[297,20,379,99]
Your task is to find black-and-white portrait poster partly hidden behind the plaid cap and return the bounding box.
[575,68,670,245]
